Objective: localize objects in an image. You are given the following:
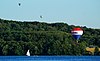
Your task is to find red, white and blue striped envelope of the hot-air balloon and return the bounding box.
[71,28,83,40]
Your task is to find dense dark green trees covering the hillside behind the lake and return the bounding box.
[0,19,100,56]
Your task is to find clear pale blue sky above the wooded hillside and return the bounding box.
[0,0,100,29]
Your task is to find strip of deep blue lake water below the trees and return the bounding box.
[0,56,100,61]
